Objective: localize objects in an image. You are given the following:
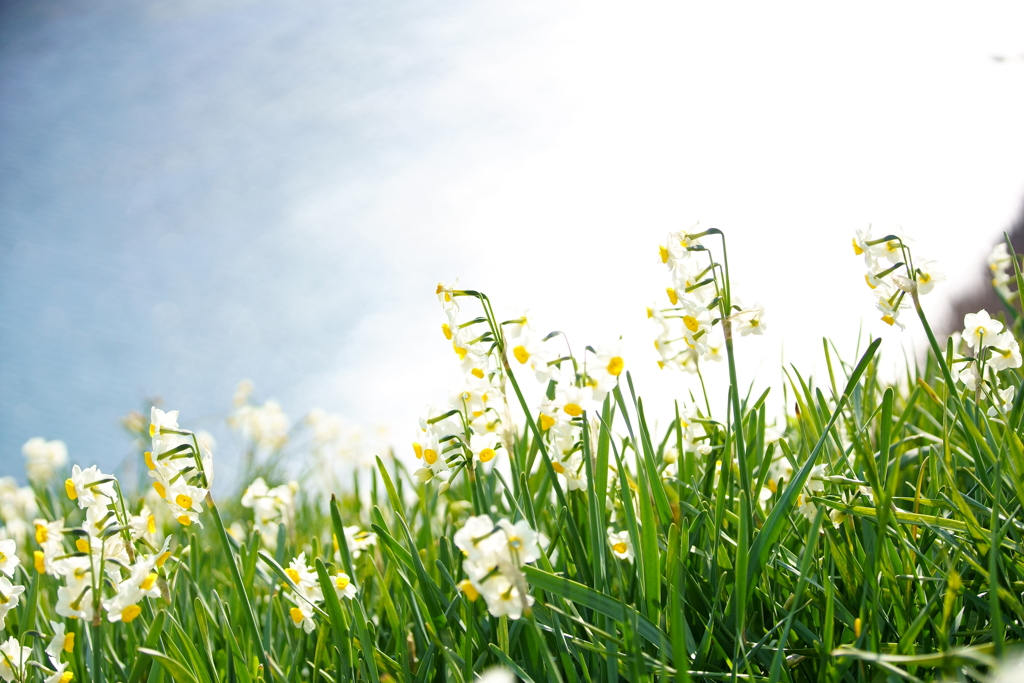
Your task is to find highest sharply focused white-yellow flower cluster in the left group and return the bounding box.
[145,407,213,526]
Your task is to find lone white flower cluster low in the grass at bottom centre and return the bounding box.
[453,515,541,620]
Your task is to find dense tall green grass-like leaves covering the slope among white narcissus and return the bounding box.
[0,230,1024,683]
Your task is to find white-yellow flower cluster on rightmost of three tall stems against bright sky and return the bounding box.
[853,225,946,330]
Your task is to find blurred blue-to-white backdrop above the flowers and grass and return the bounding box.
[0,0,1024,489]
